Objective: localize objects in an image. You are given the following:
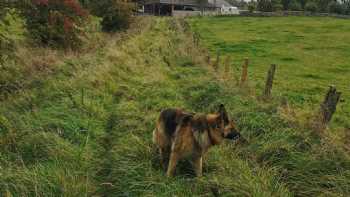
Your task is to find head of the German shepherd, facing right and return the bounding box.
[207,104,241,144]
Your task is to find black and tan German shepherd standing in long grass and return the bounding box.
[153,104,241,177]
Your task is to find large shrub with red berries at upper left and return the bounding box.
[23,0,87,48]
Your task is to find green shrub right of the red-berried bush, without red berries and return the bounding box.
[90,0,133,32]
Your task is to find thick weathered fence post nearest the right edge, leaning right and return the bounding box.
[320,86,341,125]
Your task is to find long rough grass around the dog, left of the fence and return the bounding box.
[0,17,350,197]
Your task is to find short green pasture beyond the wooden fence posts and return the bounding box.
[191,17,350,127]
